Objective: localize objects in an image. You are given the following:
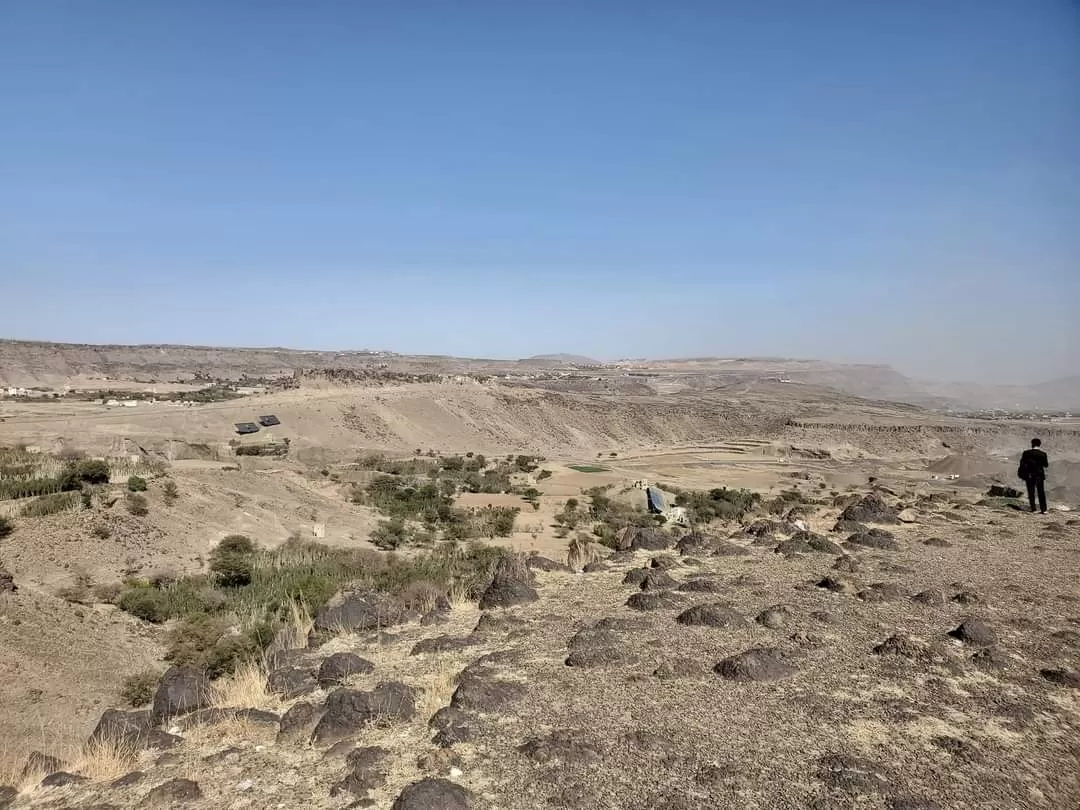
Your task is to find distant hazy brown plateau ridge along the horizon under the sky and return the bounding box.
[0,339,1080,413]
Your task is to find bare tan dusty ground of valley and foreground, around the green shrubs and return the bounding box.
[0,352,1080,810]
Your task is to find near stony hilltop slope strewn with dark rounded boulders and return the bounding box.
[0,498,1080,810]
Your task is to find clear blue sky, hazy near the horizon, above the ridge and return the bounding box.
[0,0,1080,382]
